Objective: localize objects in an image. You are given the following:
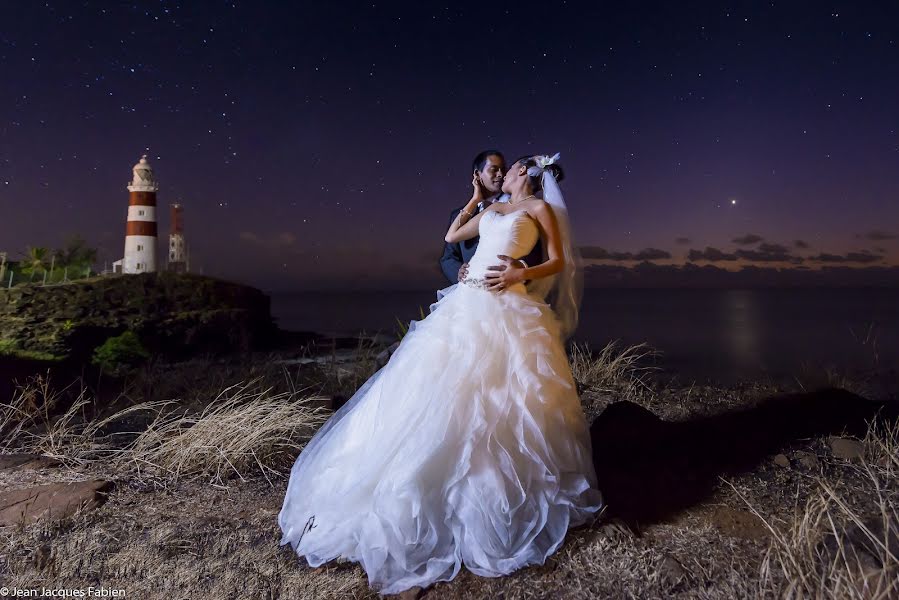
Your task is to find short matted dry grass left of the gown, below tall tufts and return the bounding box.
[0,478,378,600]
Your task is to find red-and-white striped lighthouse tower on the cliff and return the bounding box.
[121,154,159,273]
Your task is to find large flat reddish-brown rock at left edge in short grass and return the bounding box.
[0,479,112,525]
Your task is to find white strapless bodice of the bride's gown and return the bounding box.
[466,209,540,288]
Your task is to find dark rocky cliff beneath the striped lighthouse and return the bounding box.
[0,272,276,359]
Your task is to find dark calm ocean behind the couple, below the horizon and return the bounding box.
[272,288,899,380]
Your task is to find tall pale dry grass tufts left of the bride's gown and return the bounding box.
[0,376,330,485]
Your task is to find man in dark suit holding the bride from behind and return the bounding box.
[440,150,543,284]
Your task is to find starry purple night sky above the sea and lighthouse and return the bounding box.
[0,1,899,289]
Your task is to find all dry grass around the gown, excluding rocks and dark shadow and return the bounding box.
[0,342,899,600]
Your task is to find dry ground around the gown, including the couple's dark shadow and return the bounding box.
[0,350,899,600]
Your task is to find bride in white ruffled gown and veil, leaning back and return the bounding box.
[278,154,603,594]
